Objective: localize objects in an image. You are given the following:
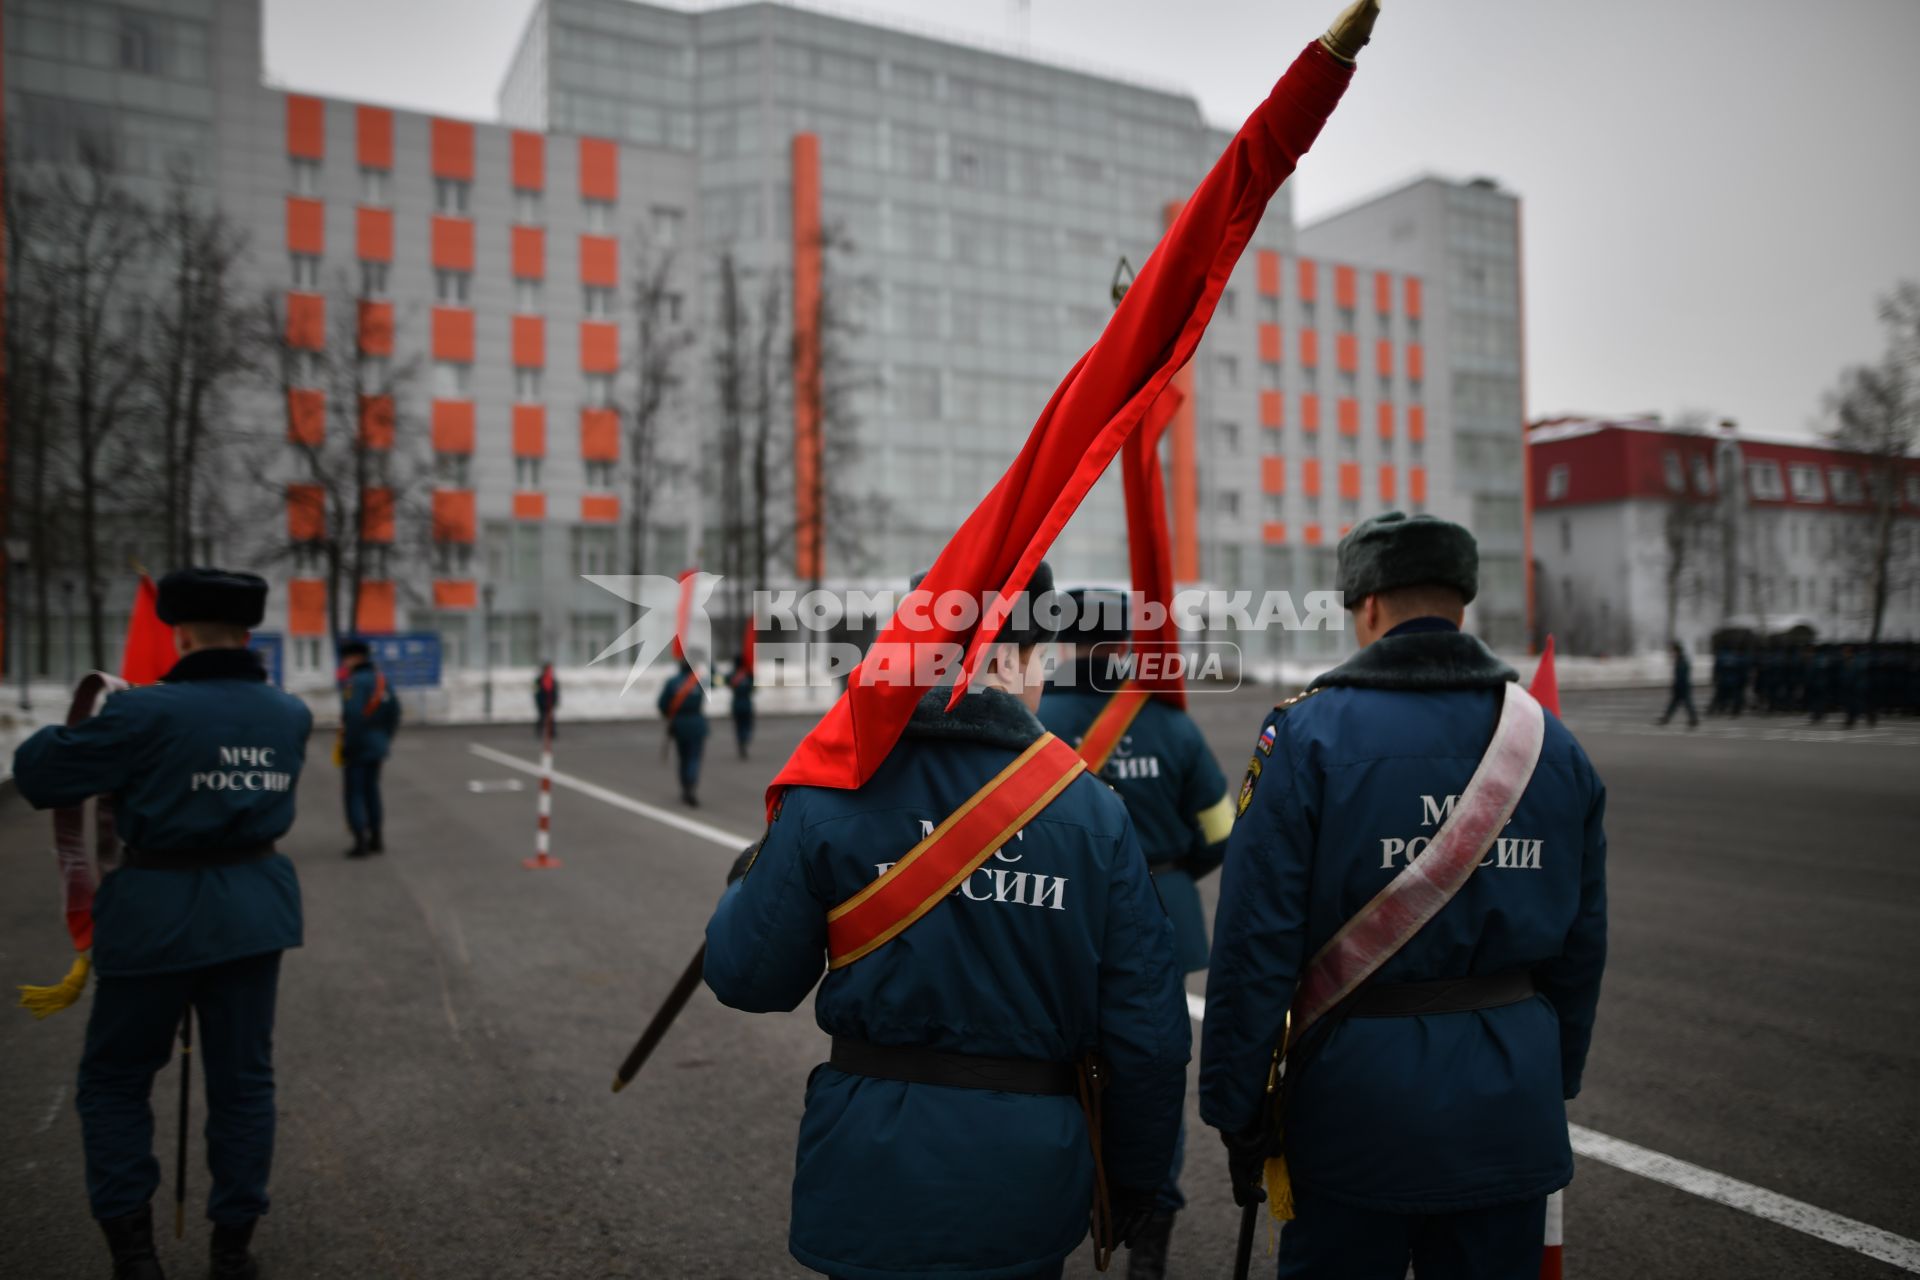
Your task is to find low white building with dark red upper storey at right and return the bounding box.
[1528,418,1920,654]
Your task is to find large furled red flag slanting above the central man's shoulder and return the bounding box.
[766,42,1354,810]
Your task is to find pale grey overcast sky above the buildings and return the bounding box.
[267,0,1920,434]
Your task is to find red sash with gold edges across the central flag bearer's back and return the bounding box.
[828,733,1087,969]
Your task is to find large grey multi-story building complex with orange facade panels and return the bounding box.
[6,0,1526,670]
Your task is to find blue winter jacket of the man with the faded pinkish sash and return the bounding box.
[1200,620,1607,1213]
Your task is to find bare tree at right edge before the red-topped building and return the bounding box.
[1828,280,1920,643]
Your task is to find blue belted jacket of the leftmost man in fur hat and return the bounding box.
[13,649,313,977]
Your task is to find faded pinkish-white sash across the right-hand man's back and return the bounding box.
[1286,681,1546,1042]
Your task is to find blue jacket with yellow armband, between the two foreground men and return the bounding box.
[1041,662,1233,973]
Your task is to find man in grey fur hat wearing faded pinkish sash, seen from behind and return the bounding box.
[1200,512,1607,1280]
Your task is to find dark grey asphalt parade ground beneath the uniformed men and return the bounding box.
[0,689,1920,1280]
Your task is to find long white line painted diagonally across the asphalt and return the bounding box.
[499,743,1920,1274]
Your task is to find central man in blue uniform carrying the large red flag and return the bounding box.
[707,564,1190,1280]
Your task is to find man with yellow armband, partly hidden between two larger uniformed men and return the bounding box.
[1041,591,1233,1280]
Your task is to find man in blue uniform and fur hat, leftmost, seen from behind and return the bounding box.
[13,570,313,1280]
